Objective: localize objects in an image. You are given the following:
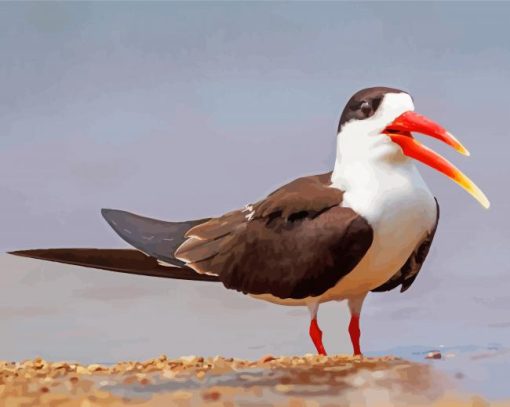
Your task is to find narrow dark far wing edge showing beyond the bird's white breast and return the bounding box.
[372,199,439,293]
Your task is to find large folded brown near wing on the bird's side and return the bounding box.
[175,174,373,299]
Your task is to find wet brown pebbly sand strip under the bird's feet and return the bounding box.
[0,355,502,407]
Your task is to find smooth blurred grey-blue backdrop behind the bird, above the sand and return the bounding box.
[0,2,510,370]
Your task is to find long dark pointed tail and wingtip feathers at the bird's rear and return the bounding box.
[10,209,219,281]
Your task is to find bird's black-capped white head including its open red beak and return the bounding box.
[338,87,490,208]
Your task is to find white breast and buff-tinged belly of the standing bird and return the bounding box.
[321,158,437,301]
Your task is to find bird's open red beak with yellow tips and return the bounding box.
[383,111,490,208]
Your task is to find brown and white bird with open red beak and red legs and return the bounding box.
[11,87,490,355]
